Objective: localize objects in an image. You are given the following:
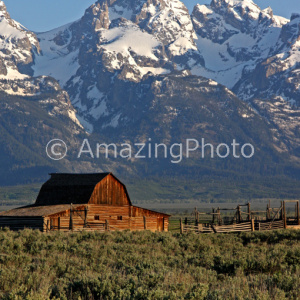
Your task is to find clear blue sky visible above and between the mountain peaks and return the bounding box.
[4,0,300,32]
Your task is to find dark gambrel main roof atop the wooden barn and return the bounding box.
[35,173,130,206]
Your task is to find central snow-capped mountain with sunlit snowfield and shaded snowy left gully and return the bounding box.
[34,0,203,131]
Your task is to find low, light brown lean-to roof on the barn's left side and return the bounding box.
[0,204,82,217]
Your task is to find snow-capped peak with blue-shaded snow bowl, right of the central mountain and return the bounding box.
[192,0,288,88]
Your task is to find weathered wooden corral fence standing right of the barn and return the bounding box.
[179,200,300,233]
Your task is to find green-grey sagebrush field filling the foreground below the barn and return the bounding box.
[0,230,300,300]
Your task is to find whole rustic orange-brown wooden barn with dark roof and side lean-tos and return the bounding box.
[0,173,169,232]
